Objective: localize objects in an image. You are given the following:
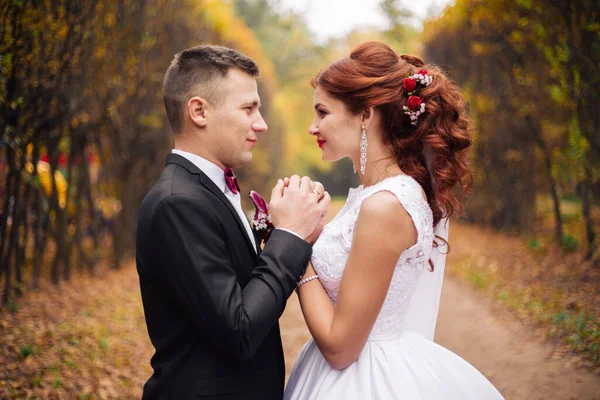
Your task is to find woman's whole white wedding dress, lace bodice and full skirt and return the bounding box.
[284,175,502,400]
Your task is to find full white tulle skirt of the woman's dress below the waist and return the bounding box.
[284,330,503,400]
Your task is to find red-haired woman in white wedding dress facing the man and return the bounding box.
[284,42,502,400]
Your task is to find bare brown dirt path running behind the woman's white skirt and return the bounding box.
[281,278,600,400]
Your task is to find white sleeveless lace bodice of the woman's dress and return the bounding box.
[311,175,434,340]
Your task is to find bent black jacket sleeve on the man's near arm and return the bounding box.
[152,195,312,360]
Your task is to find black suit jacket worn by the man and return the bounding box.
[136,154,312,400]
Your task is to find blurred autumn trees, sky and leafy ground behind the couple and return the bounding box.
[0,0,600,398]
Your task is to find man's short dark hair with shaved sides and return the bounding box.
[163,45,259,134]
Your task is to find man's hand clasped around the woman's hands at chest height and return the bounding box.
[269,175,331,243]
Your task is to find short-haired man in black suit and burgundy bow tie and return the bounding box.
[136,46,330,400]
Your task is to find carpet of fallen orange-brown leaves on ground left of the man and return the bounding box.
[0,263,153,399]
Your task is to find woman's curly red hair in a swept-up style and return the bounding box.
[311,41,472,226]
